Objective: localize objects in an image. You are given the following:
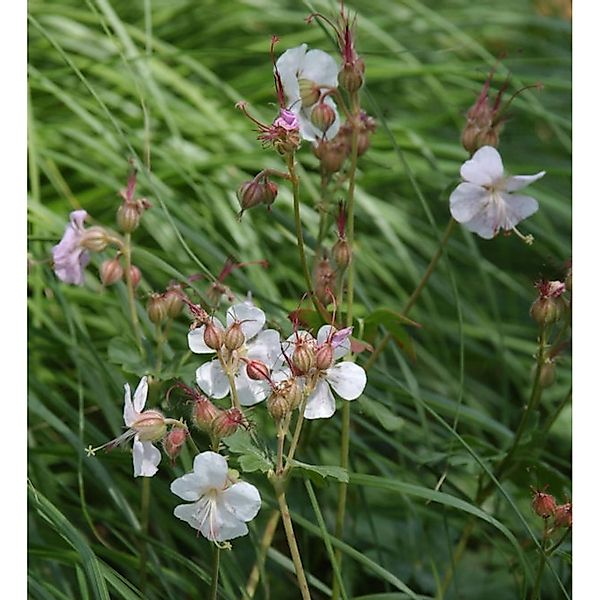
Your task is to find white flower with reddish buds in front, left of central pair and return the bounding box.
[188,302,280,406]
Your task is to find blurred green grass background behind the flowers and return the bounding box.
[28,0,571,600]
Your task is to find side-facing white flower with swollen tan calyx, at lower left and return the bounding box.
[122,377,167,477]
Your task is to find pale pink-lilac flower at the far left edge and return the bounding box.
[52,210,90,285]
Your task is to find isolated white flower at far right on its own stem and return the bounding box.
[450,146,546,243]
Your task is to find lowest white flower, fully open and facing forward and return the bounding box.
[171,452,261,542]
